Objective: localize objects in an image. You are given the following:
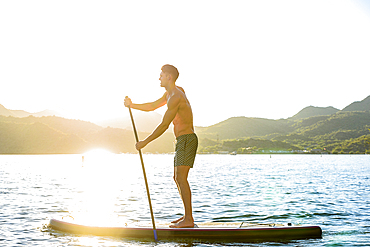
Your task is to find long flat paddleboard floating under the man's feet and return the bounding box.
[49,219,322,242]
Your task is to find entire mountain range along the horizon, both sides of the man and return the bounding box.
[0,96,370,154]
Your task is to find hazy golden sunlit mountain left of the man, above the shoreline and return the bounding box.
[0,116,174,154]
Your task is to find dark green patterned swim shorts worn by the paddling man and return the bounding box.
[174,133,198,168]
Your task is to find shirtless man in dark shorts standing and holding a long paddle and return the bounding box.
[125,64,198,228]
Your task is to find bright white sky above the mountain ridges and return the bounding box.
[0,0,370,126]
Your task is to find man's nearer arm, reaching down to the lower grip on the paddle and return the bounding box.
[136,97,180,150]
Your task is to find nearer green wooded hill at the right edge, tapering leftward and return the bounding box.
[273,111,370,153]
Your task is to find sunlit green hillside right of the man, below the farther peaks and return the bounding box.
[197,111,370,153]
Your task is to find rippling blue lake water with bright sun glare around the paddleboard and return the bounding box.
[0,153,370,247]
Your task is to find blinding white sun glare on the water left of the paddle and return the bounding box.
[67,149,139,226]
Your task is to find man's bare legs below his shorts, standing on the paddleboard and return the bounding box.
[170,166,194,228]
